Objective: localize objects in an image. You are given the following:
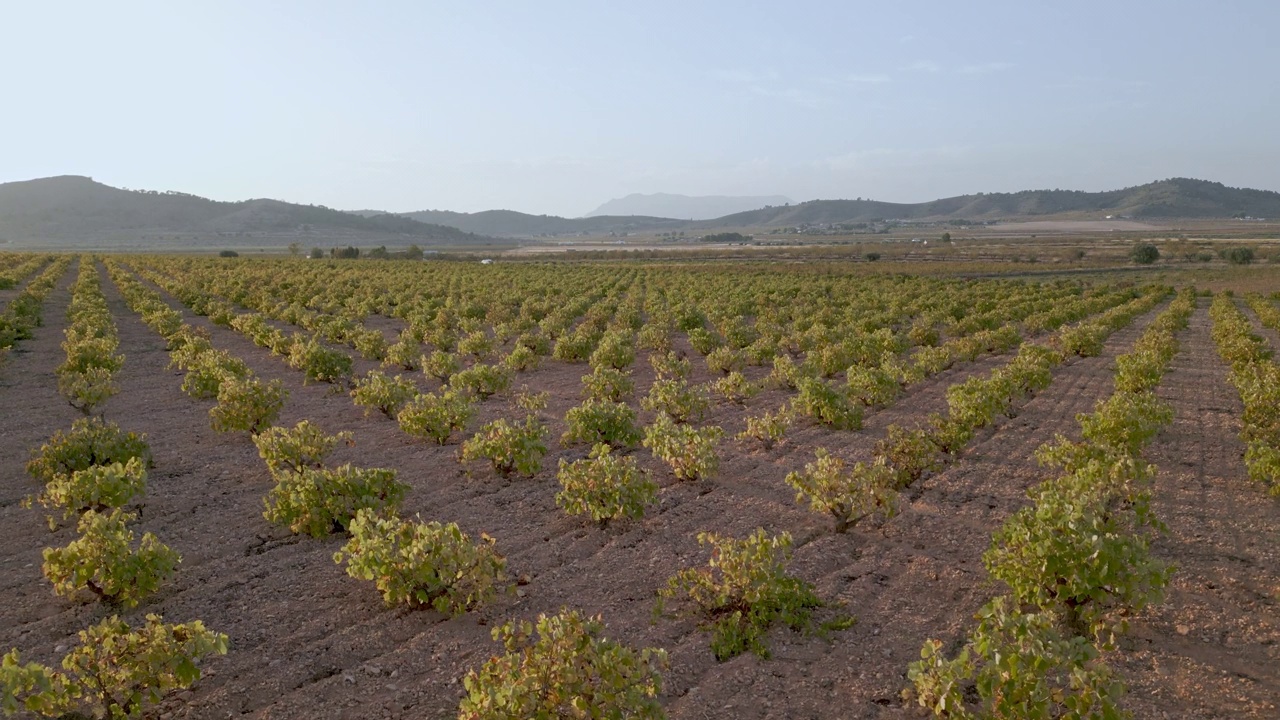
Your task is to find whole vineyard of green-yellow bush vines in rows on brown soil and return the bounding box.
[0,252,1280,719]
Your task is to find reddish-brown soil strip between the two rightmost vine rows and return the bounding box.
[1111,301,1280,717]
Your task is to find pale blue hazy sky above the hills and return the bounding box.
[0,0,1280,215]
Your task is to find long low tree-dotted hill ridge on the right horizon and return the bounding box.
[698,178,1280,228]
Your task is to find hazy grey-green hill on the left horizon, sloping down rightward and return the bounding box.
[0,176,486,247]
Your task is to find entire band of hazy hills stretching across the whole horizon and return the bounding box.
[0,176,1280,250]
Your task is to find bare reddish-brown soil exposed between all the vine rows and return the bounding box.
[0,269,1280,719]
